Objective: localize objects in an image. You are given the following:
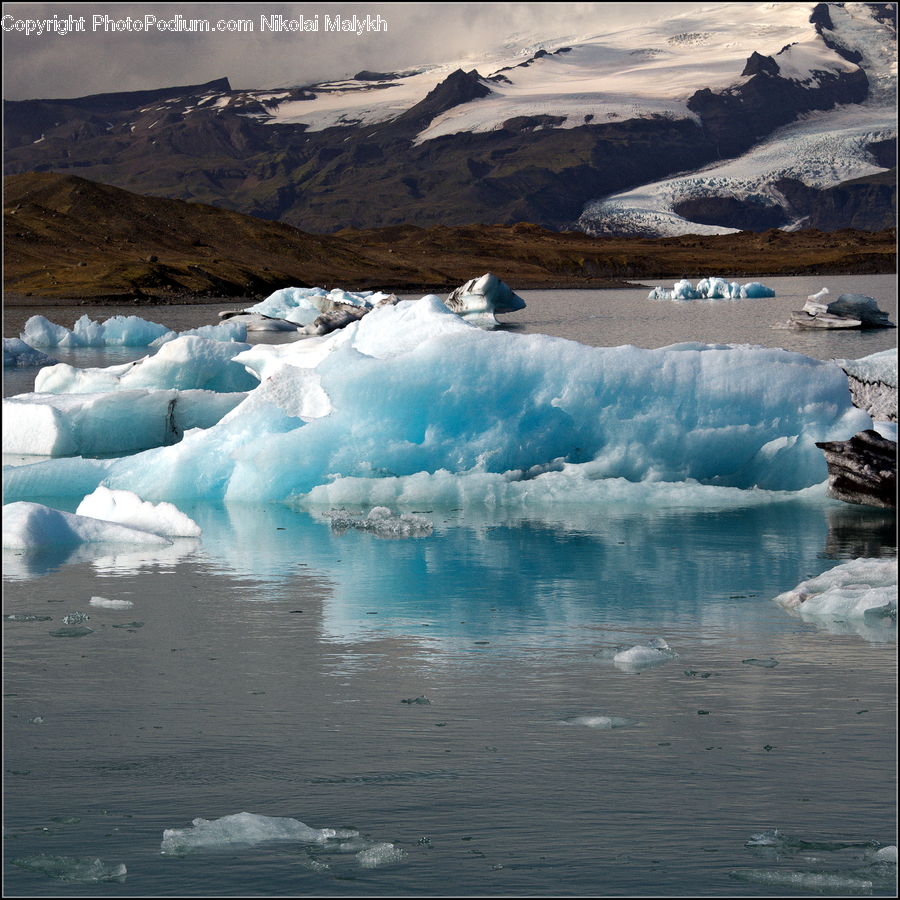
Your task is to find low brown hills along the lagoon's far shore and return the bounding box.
[3,173,896,305]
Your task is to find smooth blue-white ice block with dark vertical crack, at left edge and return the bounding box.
[3,388,244,456]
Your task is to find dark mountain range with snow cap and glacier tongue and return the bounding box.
[4,3,896,236]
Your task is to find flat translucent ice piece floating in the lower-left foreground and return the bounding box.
[160,812,358,856]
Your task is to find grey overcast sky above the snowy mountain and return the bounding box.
[3,2,708,100]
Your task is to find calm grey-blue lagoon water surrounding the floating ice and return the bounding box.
[4,278,896,897]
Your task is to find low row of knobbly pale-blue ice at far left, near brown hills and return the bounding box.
[20,316,247,349]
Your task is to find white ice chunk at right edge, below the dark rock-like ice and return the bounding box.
[774,559,897,626]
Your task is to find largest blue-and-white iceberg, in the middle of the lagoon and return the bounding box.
[4,296,871,506]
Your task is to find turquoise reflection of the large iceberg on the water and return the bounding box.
[184,502,848,654]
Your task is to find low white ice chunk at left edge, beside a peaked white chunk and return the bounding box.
[3,501,171,550]
